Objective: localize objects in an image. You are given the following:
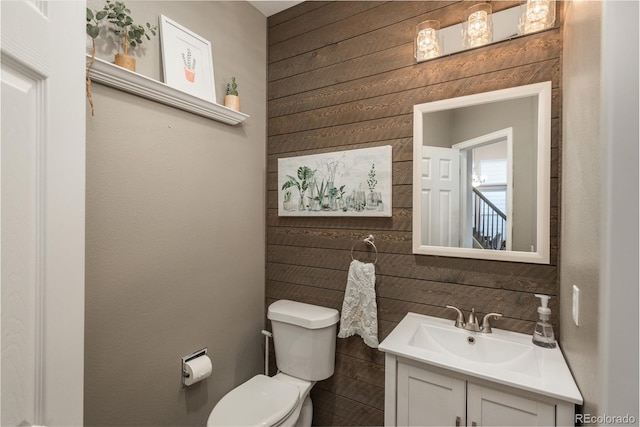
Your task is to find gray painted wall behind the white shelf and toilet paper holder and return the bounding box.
[84,1,266,425]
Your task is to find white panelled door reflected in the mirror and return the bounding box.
[421,146,460,247]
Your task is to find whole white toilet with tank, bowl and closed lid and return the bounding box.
[207,300,338,427]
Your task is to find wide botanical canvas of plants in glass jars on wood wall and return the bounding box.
[278,145,392,217]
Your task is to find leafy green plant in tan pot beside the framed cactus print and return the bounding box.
[103,0,158,71]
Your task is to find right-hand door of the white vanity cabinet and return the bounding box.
[467,382,555,427]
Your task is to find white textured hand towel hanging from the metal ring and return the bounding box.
[338,260,378,348]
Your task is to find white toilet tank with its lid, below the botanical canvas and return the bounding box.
[267,300,338,381]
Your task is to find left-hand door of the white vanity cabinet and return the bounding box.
[396,363,466,426]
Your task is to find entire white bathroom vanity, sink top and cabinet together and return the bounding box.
[378,313,583,426]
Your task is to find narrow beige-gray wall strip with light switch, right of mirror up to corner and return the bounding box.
[560,2,603,414]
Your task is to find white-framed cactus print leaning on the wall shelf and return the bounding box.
[160,15,216,102]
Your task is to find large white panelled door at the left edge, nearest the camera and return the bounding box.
[0,0,86,426]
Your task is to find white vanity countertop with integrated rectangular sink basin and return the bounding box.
[378,313,582,405]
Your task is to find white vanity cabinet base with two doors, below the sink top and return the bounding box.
[385,353,574,427]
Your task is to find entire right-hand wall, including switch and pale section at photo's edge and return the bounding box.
[560,2,638,425]
